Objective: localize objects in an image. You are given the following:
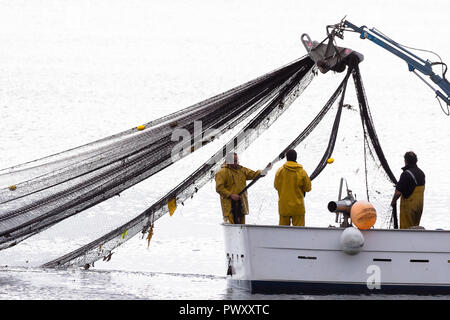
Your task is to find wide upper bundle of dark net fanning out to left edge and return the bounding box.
[0,57,313,249]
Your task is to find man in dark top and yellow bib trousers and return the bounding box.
[391,151,425,229]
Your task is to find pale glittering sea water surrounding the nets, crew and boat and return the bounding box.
[0,0,450,300]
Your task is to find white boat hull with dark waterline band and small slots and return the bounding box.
[223,224,450,294]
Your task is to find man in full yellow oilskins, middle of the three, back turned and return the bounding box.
[274,149,311,226]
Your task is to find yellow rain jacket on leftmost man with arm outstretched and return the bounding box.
[216,163,261,217]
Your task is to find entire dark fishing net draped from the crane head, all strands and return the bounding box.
[0,52,396,268]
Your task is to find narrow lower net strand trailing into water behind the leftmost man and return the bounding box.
[43,58,314,268]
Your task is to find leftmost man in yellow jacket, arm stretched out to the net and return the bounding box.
[216,153,264,224]
